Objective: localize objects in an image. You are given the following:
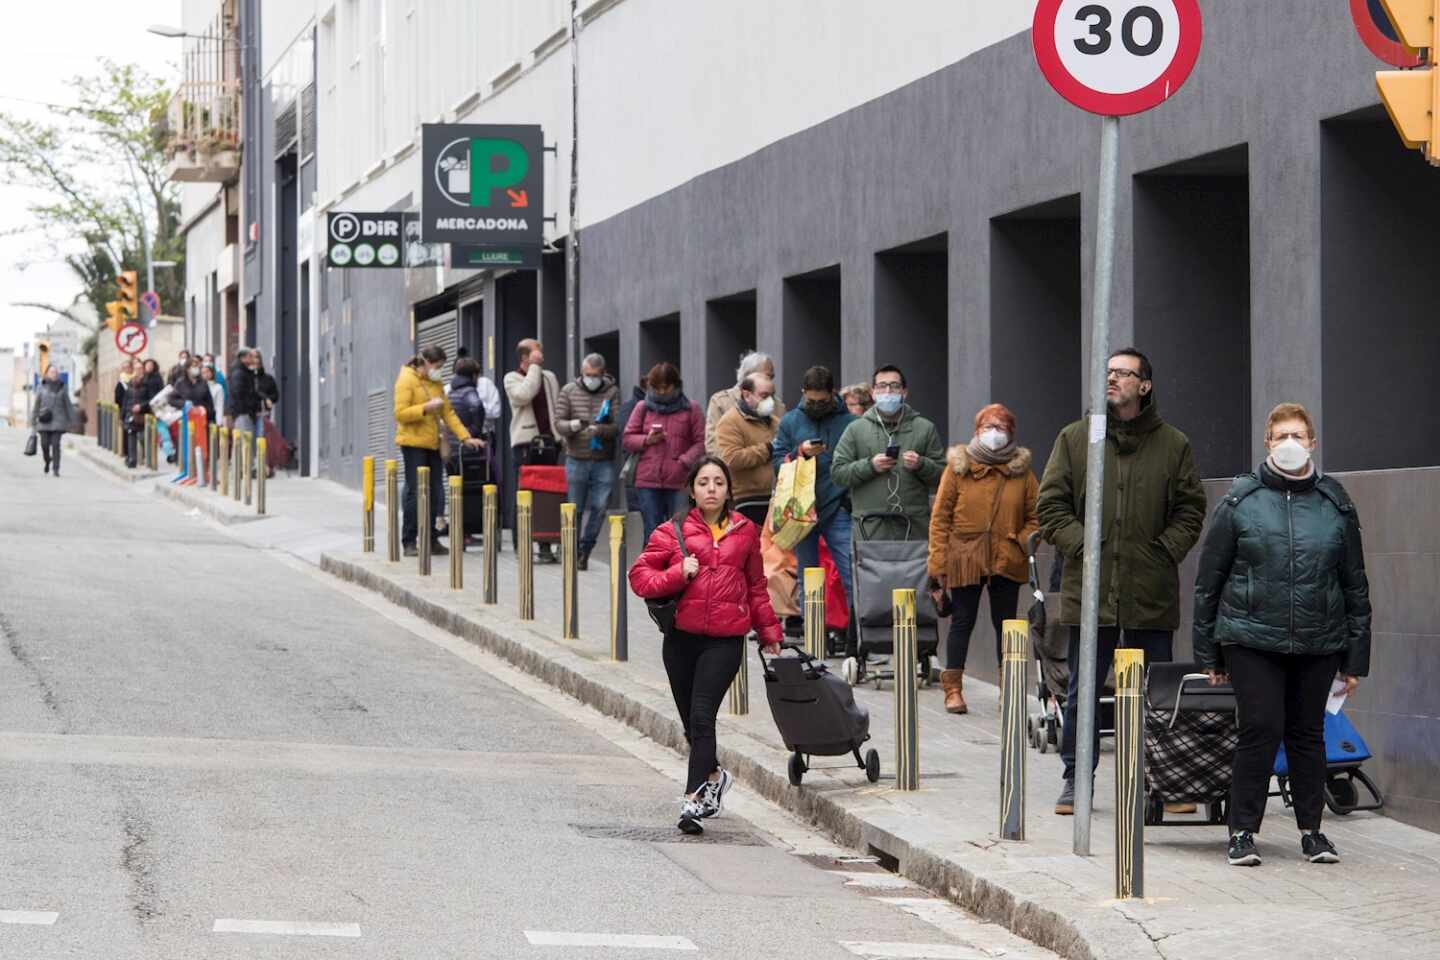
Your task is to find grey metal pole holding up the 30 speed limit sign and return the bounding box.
[1071,117,1120,856]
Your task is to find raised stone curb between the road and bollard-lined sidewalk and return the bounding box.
[320,554,1140,960]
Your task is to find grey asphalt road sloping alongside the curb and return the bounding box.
[0,429,1051,960]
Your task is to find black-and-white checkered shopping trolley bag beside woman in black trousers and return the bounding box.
[1145,664,1240,825]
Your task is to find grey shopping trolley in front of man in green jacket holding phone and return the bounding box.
[841,517,940,689]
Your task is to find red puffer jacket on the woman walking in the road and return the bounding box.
[629,510,782,643]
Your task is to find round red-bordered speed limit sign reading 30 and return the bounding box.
[1032,0,1204,117]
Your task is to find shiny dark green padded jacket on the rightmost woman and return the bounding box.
[1194,463,1371,676]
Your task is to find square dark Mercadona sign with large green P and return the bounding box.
[420,124,544,248]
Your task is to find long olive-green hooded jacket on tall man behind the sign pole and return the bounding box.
[1035,390,1205,630]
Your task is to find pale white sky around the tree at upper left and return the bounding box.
[0,0,181,347]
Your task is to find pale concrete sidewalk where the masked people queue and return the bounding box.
[95,454,1440,960]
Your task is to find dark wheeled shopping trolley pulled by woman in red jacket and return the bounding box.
[760,643,880,786]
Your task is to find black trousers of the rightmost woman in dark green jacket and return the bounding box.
[1224,645,1341,833]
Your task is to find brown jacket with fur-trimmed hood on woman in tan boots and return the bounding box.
[929,443,1040,589]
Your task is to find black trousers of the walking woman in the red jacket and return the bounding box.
[661,630,744,794]
